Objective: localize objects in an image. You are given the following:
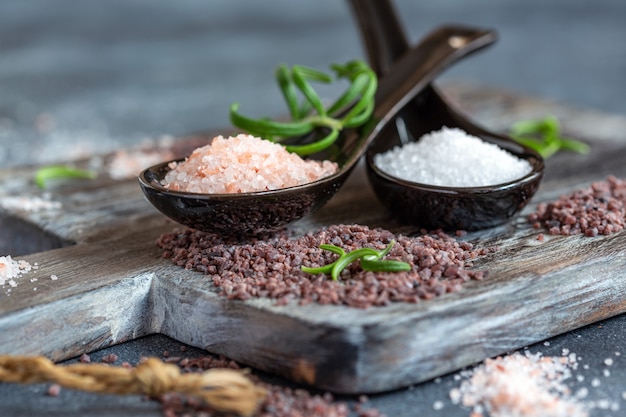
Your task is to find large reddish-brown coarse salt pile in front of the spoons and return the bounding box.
[157,224,492,308]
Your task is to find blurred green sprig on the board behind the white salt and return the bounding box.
[509,116,589,159]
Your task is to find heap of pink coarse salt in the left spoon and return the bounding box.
[162,134,337,194]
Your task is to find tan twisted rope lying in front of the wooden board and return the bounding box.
[0,355,265,416]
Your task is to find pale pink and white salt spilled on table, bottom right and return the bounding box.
[449,352,589,417]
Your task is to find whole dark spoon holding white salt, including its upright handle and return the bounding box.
[350,0,544,230]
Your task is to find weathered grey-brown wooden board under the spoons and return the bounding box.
[0,85,626,393]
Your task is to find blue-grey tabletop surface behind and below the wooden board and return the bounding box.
[0,0,626,417]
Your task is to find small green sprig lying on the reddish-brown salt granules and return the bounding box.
[300,240,411,281]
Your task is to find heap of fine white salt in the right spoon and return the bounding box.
[374,127,532,187]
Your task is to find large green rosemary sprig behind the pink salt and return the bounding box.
[230,60,378,156]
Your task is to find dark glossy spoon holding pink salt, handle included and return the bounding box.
[139,26,494,236]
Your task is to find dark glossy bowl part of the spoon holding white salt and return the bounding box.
[366,87,544,231]
